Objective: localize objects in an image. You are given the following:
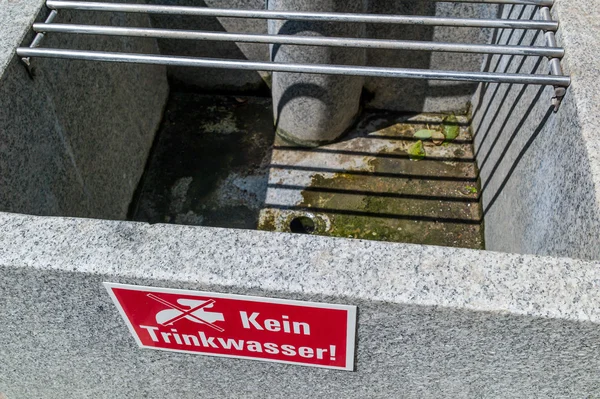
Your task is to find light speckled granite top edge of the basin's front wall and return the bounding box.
[0,213,600,323]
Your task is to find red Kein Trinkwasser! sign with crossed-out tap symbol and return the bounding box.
[104,283,356,371]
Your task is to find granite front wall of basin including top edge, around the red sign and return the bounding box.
[0,214,600,399]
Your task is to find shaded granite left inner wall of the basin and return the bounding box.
[0,2,168,219]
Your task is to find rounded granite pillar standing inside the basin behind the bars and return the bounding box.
[268,0,367,147]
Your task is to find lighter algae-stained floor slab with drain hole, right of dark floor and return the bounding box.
[259,112,483,248]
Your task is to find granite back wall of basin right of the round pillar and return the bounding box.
[365,0,498,112]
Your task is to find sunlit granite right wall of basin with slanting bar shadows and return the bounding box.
[473,2,600,259]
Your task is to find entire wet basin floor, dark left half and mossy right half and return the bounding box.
[132,92,484,248]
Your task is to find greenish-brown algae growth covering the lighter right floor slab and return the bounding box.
[261,111,483,249]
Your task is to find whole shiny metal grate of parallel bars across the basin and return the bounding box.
[17,0,571,109]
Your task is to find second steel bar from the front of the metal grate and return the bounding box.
[33,24,564,58]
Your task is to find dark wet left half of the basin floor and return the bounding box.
[130,92,274,229]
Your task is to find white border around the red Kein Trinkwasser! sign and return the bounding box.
[102,282,357,371]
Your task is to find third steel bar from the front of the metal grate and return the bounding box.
[46,0,558,30]
